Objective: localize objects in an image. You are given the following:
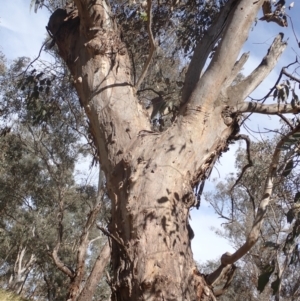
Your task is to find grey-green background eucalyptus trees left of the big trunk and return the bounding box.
[0,58,110,301]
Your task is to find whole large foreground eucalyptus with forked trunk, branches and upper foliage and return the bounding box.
[17,0,299,300]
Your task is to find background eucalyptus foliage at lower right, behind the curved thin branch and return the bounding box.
[205,134,300,300]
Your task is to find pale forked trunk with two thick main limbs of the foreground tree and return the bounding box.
[48,0,288,301]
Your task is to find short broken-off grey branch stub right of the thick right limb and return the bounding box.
[228,33,287,100]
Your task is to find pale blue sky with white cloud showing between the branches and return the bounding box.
[0,0,300,262]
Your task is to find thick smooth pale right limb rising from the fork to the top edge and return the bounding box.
[187,0,263,114]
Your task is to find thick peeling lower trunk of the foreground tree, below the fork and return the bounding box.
[109,120,231,300]
